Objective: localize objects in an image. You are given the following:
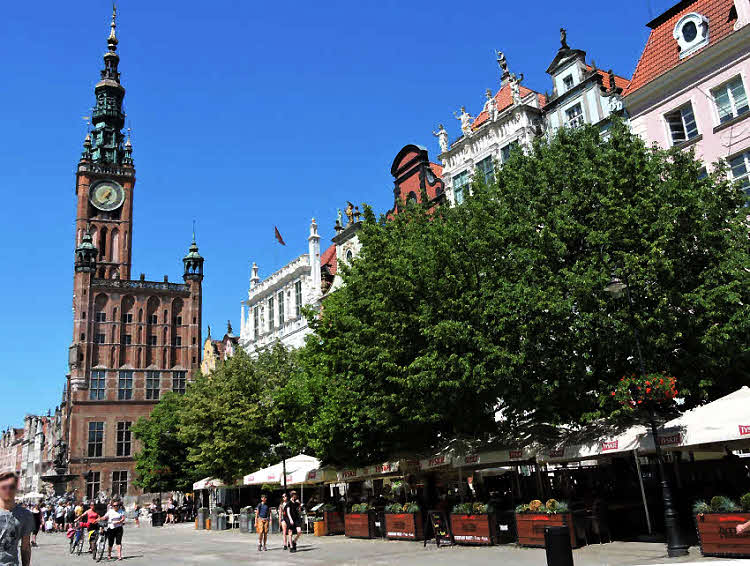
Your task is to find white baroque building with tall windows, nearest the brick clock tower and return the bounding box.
[240,218,336,355]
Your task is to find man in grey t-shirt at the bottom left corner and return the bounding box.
[0,472,34,566]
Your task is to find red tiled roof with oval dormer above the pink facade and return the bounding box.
[625,0,734,96]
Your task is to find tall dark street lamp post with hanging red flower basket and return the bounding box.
[604,273,688,558]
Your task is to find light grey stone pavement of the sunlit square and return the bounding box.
[32,523,724,566]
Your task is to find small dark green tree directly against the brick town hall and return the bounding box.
[133,392,199,493]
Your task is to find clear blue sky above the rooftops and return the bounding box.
[0,0,672,428]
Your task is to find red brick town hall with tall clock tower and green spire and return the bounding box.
[63,6,204,499]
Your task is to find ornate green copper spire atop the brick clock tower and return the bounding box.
[91,5,132,166]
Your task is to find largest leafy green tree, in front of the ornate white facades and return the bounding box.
[296,123,750,464]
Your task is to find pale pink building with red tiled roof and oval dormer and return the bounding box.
[624,0,750,191]
